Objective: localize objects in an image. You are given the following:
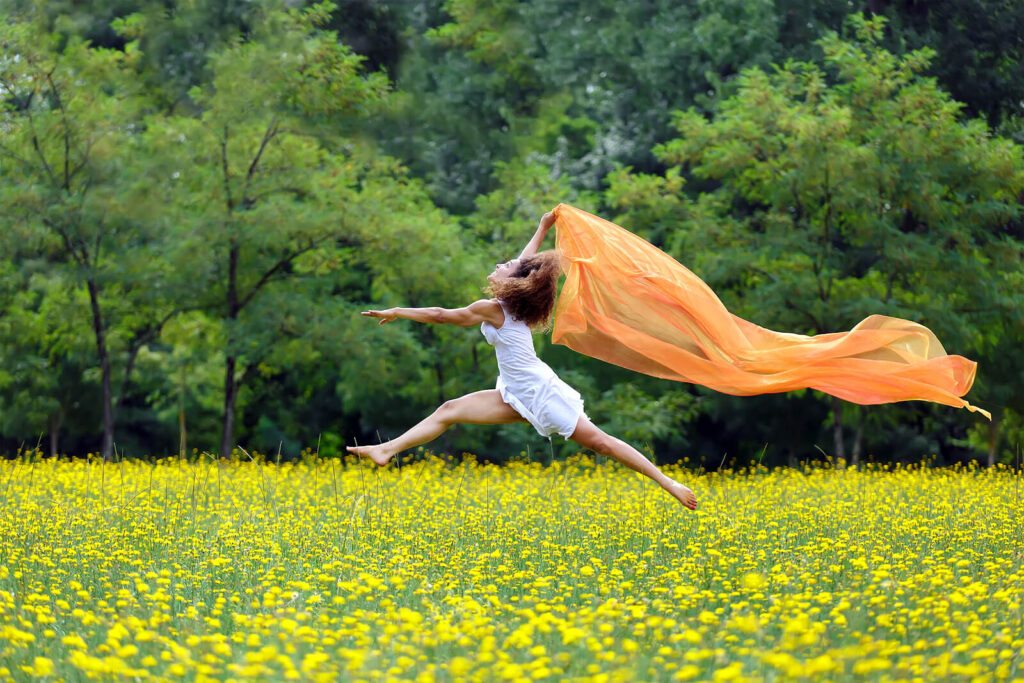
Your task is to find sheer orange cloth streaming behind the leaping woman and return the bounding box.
[552,204,988,417]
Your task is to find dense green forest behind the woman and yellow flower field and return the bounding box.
[0,0,1024,468]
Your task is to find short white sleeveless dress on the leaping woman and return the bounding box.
[480,301,586,438]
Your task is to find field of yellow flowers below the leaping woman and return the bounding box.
[0,454,1024,681]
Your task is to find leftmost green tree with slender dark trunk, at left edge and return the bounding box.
[0,22,175,458]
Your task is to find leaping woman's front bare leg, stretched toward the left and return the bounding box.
[345,389,525,466]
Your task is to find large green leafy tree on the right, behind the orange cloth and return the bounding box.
[611,15,1024,457]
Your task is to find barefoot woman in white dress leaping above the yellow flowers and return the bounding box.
[348,212,697,510]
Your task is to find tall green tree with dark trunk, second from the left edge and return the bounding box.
[147,4,483,456]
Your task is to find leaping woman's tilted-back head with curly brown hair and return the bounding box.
[487,250,562,330]
